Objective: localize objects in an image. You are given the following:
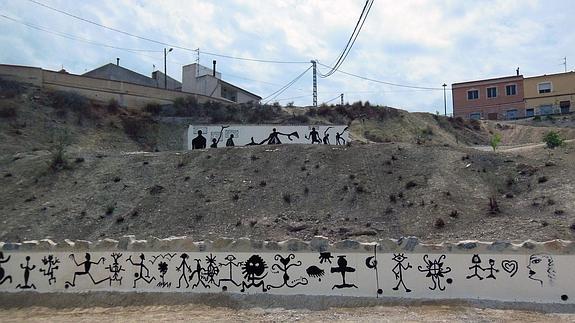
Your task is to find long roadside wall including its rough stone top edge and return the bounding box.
[0,236,575,304]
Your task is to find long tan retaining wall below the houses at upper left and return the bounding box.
[0,65,232,108]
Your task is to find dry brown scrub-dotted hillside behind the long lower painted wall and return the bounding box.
[0,80,575,241]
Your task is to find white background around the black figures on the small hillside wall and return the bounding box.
[188,125,349,149]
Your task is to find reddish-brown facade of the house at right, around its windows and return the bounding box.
[452,76,525,119]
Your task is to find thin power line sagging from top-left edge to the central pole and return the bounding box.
[28,0,308,64]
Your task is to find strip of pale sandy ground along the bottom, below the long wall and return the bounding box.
[0,305,575,322]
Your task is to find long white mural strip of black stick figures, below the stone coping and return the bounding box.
[0,246,575,303]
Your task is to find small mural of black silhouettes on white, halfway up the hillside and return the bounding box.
[188,125,349,149]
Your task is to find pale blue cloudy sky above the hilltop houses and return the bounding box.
[0,0,575,113]
